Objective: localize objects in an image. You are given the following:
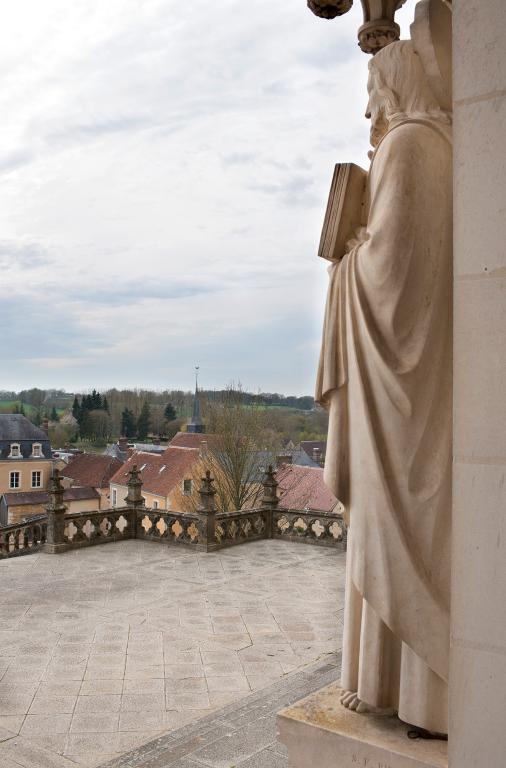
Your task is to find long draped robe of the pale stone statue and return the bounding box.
[317,119,452,733]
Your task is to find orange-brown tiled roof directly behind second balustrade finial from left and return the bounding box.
[110,446,199,496]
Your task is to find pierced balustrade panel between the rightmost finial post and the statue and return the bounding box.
[272,509,347,550]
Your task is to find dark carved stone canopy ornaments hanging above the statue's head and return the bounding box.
[308,0,406,54]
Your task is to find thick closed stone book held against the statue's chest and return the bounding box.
[318,163,367,261]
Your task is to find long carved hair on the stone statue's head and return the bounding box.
[369,40,449,123]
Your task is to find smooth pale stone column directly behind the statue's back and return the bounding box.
[449,0,506,768]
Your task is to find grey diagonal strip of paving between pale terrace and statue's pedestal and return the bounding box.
[102,654,341,768]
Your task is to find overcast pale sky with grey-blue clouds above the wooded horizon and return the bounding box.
[0,0,412,394]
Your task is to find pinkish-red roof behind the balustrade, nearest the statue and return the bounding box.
[276,464,339,512]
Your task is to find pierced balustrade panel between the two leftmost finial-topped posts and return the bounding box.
[63,507,135,549]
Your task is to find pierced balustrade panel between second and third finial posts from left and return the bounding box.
[137,509,202,547]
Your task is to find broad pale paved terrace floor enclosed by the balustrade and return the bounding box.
[0,540,345,768]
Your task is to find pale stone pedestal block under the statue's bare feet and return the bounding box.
[278,683,448,768]
